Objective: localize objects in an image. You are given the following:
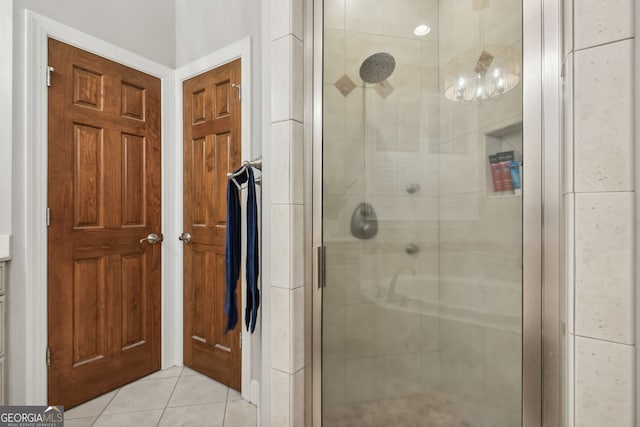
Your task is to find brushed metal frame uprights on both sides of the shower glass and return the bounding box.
[304,0,563,427]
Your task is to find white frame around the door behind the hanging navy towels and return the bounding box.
[173,37,261,403]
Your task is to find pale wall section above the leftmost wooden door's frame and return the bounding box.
[13,0,176,68]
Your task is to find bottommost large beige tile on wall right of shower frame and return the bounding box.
[575,337,635,427]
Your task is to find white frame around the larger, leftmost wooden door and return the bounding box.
[21,10,176,404]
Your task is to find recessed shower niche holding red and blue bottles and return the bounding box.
[484,122,524,197]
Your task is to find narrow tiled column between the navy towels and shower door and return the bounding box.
[263,0,305,427]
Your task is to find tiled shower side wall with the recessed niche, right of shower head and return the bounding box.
[438,0,527,427]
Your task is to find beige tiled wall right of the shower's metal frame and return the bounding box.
[563,0,636,427]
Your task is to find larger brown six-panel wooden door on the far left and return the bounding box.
[48,39,160,407]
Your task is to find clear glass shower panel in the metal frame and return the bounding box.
[322,0,526,427]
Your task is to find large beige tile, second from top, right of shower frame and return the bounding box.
[574,40,634,192]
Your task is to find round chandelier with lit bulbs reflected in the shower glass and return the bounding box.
[444,45,520,103]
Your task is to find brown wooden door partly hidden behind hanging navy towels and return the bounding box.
[183,59,242,390]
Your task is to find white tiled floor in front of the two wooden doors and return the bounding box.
[64,366,257,427]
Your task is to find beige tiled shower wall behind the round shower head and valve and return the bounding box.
[323,0,440,413]
